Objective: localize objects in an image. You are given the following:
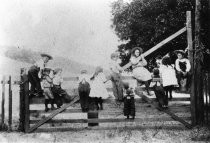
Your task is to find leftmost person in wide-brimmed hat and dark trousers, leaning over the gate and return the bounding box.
[28,54,53,96]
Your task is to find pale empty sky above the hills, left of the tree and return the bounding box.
[0,0,123,67]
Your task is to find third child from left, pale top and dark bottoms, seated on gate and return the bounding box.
[52,68,72,108]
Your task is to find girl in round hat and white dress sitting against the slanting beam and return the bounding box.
[130,47,152,95]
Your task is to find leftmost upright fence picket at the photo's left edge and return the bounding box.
[1,76,5,126]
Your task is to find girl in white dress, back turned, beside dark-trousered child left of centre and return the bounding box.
[90,67,109,110]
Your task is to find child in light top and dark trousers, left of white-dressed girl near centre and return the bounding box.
[78,70,90,112]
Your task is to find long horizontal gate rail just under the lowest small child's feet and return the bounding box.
[30,117,191,124]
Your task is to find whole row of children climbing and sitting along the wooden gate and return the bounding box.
[28,49,189,119]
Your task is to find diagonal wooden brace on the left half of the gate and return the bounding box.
[27,96,79,133]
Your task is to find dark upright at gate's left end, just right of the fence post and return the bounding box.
[23,72,30,133]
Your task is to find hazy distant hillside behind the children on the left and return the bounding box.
[0,46,95,75]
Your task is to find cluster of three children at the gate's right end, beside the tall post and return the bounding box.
[153,50,191,108]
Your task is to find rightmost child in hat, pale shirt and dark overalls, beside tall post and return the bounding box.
[175,50,191,89]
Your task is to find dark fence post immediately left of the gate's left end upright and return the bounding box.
[18,68,25,131]
